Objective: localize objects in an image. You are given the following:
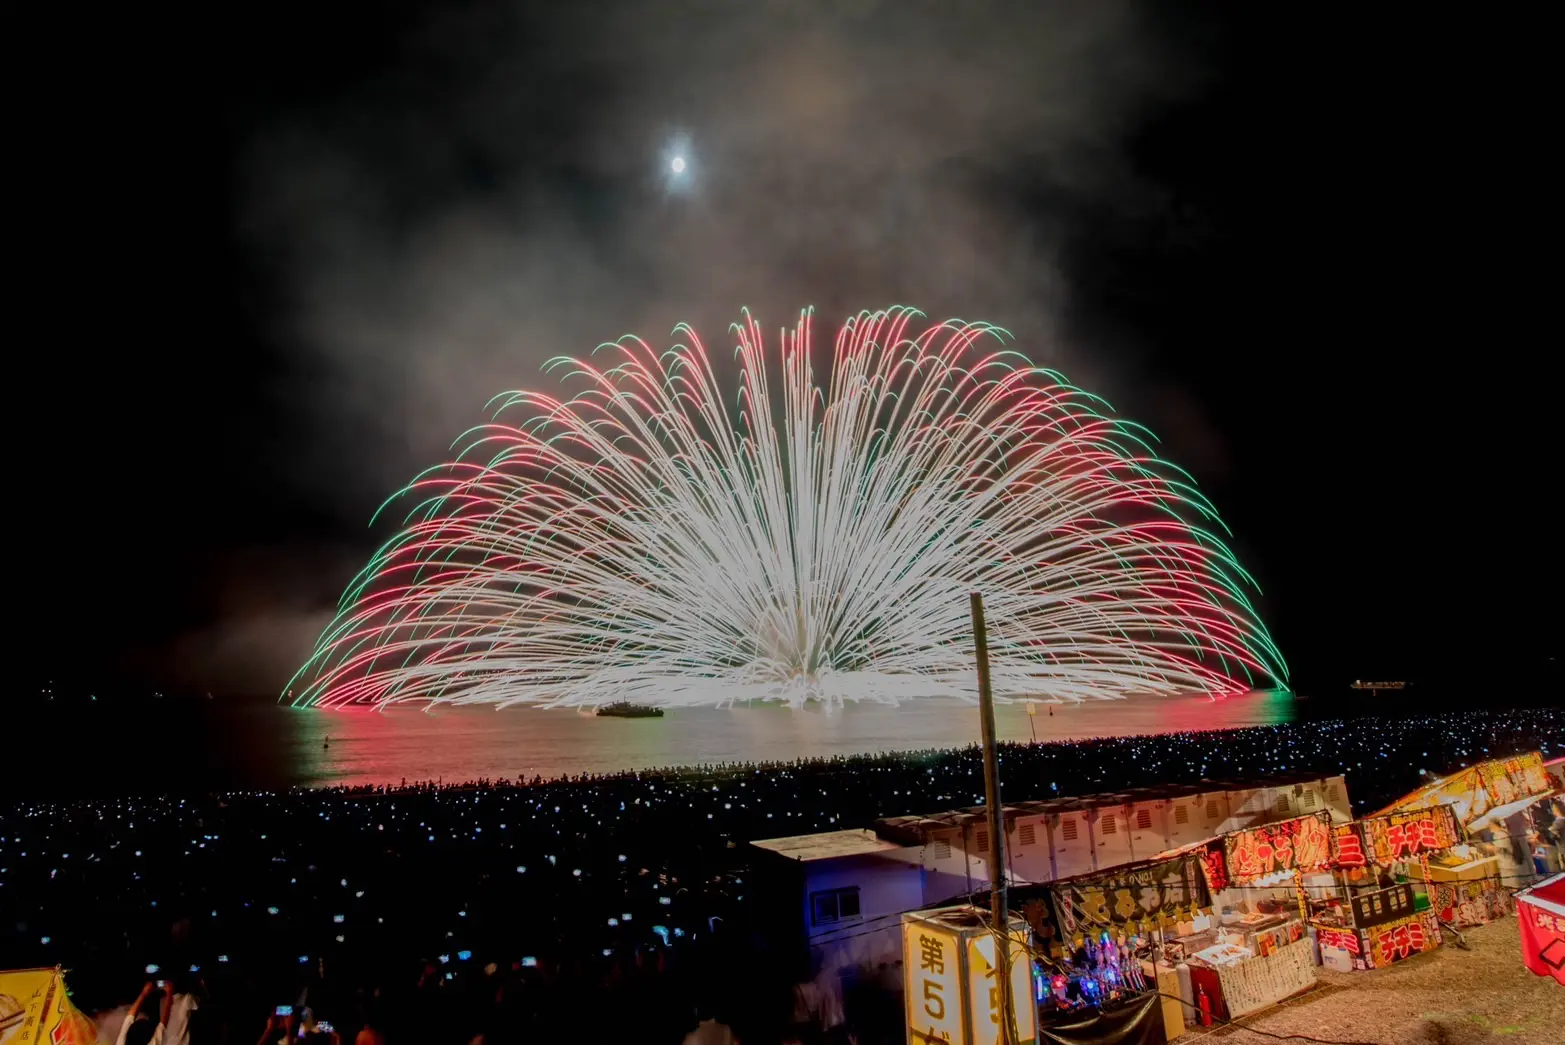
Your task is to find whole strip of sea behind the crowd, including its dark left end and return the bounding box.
[18,691,1304,793]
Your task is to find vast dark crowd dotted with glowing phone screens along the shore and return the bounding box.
[0,709,1565,1045]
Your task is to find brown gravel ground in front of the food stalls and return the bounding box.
[1178,917,1565,1045]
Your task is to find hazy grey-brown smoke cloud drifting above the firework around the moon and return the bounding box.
[203,0,1199,688]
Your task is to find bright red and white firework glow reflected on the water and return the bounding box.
[281,691,1294,785]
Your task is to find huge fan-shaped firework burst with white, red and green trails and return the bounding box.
[291,308,1285,707]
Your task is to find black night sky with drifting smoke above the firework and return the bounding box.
[18,0,1562,693]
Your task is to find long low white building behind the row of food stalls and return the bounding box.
[753,774,1352,970]
